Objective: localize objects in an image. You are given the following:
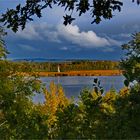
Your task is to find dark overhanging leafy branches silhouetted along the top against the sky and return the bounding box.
[0,0,140,32]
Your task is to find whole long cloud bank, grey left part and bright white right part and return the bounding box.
[10,23,121,51]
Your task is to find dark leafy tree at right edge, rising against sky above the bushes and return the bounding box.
[121,33,140,86]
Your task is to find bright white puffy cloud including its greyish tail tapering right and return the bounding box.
[57,25,122,52]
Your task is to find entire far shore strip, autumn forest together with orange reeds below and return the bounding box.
[0,60,122,76]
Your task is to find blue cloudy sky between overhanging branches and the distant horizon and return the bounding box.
[0,0,140,60]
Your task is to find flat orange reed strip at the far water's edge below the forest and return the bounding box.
[35,70,123,77]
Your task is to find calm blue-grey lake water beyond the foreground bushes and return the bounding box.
[34,76,124,102]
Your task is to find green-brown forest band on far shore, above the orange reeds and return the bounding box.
[13,60,120,72]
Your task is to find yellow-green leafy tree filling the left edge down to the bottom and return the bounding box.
[0,28,48,139]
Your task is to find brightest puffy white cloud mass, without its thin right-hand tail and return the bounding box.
[57,25,110,48]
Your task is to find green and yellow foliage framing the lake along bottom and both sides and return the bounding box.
[0,1,140,139]
